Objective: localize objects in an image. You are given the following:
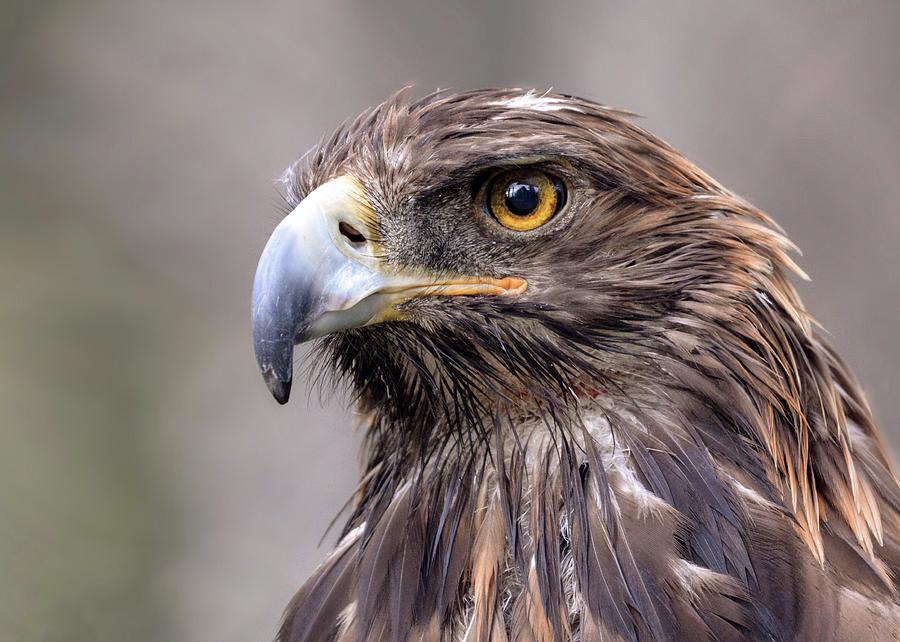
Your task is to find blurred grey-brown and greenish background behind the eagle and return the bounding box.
[0,0,900,642]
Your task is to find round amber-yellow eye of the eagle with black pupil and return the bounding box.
[487,169,566,232]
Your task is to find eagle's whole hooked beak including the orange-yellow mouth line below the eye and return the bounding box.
[252,175,528,404]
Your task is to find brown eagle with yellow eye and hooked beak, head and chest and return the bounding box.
[252,89,900,642]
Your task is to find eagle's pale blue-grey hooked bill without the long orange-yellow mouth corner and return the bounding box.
[252,177,385,404]
